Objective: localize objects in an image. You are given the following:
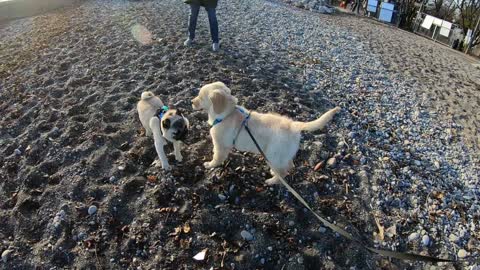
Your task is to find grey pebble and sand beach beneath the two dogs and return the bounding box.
[0,0,480,270]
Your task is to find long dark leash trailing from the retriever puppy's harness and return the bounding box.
[245,124,457,262]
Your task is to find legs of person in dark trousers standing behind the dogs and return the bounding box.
[183,0,220,52]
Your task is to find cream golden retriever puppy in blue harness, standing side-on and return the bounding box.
[192,82,340,185]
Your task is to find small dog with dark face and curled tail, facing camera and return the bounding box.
[137,91,190,171]
